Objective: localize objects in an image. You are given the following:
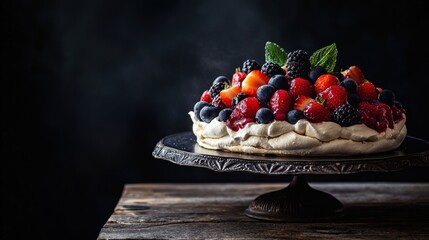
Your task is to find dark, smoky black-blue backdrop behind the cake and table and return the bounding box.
[1,0,429,239]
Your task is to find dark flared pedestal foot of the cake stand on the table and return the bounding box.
[245,175,344,222]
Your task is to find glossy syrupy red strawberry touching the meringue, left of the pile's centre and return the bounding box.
[226,97,260,131]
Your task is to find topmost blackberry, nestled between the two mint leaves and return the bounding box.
[286,50,311,78]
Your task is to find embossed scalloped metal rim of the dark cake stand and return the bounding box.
[152,135,429,175]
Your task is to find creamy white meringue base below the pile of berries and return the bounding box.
[189,111,407,156]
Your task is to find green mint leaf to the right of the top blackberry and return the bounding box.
[310,43,338,72]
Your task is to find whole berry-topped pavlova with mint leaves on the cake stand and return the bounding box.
[189,42,407,156]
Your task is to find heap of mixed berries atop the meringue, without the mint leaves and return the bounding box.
[194,50,405,132]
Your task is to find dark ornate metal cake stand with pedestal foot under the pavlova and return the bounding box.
[152,132,429,222]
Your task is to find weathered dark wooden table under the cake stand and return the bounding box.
[98,183,429,240]
